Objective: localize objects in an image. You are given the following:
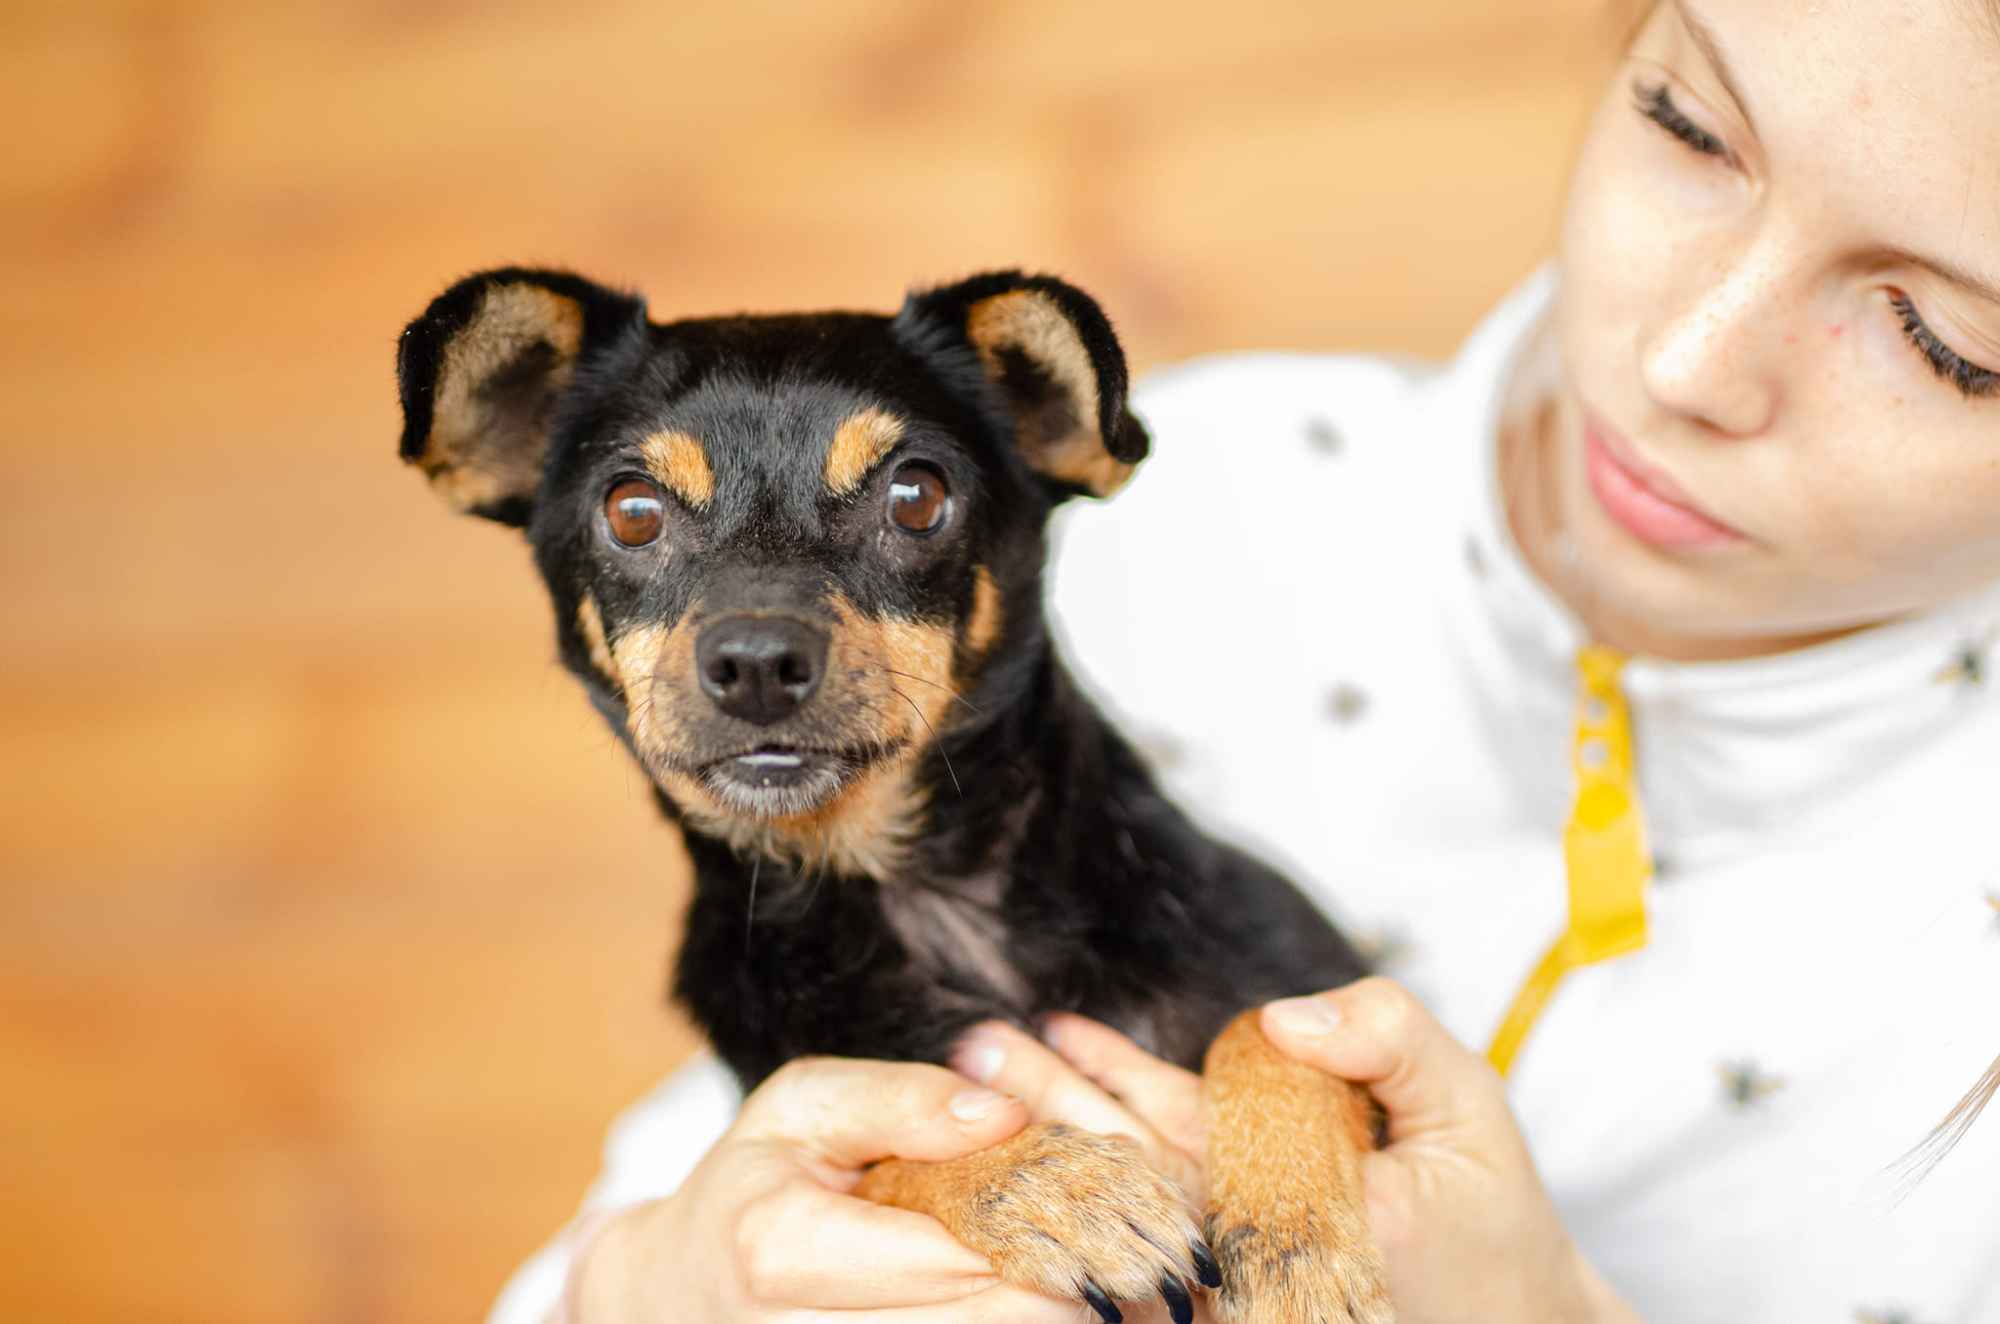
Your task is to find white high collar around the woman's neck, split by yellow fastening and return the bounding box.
[1436,268,2000,864]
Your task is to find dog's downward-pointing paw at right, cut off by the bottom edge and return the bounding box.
[1208,1208,1396,1324]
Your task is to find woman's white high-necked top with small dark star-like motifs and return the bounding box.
[492,272,2000,1324]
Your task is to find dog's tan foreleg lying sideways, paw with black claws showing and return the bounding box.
[854,1122,1214,1320]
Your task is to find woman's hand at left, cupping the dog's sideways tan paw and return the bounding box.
[572,1058,1076,1324]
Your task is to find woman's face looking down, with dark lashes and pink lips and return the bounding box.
[1516,0,2000,656]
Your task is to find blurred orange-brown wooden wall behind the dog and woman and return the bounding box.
[0,0,1610,1324]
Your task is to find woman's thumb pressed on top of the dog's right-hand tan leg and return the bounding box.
[1262,978,1506,1142]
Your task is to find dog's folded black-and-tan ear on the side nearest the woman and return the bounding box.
[896,272,1148,496]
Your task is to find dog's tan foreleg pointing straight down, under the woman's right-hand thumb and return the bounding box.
[1202,1012,1394,1324]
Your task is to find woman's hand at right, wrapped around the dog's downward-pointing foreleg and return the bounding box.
[954,978,1636,1324]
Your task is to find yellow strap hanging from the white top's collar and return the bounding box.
[1486,646,1652,1076]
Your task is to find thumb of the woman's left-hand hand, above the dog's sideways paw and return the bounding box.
[732,1058,1028,1190]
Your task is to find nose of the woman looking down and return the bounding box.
[1640,256,1784,436]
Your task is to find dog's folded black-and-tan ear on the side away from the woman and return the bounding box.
[396,266,646,526]
